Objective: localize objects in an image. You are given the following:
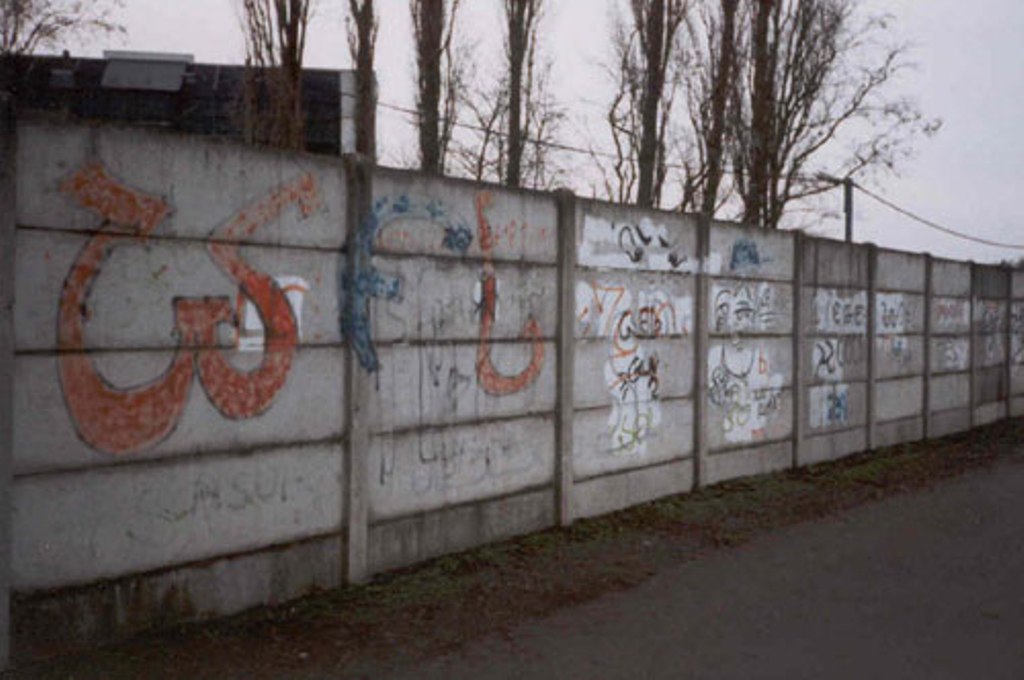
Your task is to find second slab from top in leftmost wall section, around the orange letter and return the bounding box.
[15,230,341,353]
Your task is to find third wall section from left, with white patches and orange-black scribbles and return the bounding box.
[572,203,698,517]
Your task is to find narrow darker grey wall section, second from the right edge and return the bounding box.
[974,265,1011,426]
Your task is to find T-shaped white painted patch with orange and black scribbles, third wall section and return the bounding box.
[575,282,693,455]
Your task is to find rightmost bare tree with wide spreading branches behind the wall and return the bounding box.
[730,0,940,228]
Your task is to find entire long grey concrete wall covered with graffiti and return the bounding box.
[6,116,1024,655]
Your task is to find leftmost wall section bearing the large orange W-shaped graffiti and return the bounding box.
[11,123,345,654]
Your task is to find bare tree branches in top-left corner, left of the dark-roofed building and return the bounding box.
[0,0,124,89]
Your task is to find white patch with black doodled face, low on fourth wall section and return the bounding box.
[708,340,782,442]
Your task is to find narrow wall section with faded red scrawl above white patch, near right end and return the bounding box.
[928,258,971,437]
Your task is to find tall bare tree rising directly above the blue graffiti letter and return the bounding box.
[410,0,467,174]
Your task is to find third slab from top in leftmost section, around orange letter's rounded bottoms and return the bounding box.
[14,347,344,474]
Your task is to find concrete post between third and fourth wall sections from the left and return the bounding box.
[693,216,711,490]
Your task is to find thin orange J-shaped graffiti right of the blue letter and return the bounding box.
[476,192,544,396]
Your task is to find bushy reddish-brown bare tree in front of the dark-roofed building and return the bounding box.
[242,0,315,148]
